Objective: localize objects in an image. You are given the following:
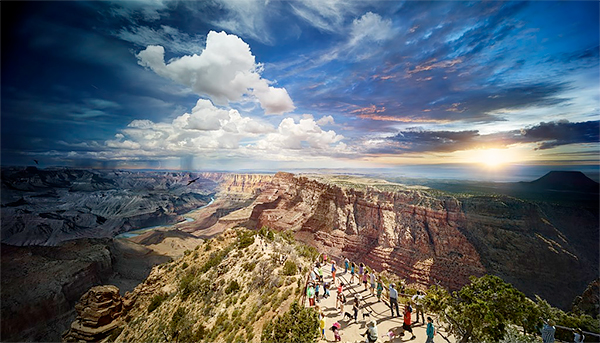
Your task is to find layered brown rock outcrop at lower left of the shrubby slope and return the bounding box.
[63,285,124,342]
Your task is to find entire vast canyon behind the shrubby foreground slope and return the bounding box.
[1,167,599,341]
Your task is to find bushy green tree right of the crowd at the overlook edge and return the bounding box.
[426,275,538,343]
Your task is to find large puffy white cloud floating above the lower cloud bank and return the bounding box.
[137,31,294,114]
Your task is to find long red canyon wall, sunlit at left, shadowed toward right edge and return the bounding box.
[251,173,598,308]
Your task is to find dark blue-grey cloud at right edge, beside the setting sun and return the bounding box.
[521,120,600,150]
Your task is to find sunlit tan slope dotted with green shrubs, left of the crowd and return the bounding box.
[116,229,318,343]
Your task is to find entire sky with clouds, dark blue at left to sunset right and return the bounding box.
[1,0,600,177]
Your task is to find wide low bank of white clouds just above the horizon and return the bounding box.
[104,99,347,160]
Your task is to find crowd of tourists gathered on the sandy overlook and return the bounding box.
[306,254,436,343]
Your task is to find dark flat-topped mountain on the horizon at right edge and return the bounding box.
[528,171,600,193]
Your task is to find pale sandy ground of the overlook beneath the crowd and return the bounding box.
[305,263,455,343]
